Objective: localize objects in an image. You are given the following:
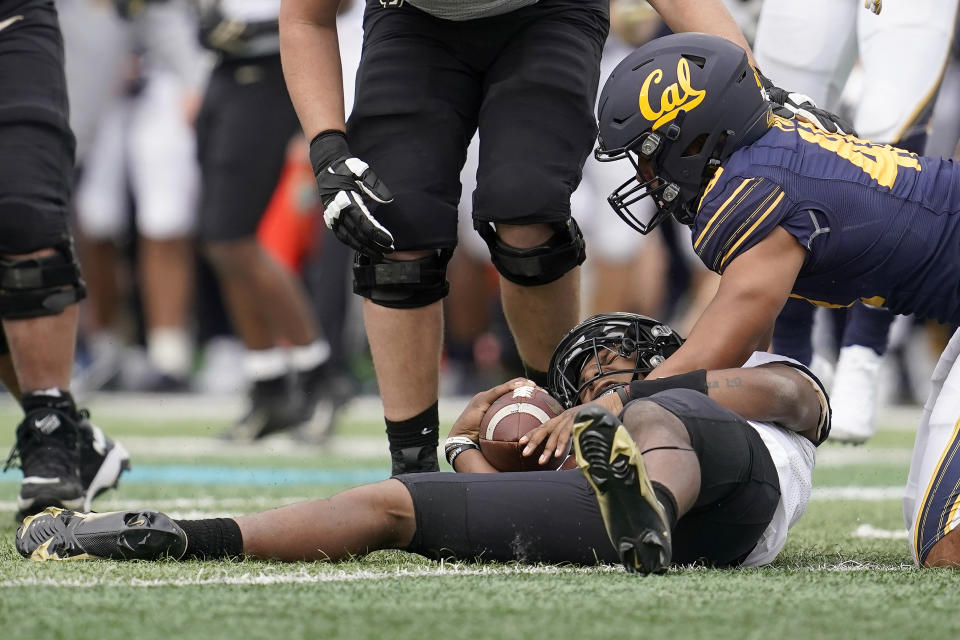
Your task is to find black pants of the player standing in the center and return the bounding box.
[347,0,609,249]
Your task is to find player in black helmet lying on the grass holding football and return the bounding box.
[16,314,830,573]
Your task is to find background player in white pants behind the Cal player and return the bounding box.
[754,0,957,443]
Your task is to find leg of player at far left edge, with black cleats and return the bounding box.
[0,0,129,519]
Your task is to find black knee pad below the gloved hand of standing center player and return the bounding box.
[353,249,453,309]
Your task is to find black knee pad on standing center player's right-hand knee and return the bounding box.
[473,218,587,287]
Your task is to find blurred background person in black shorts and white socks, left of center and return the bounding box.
[197,0,344,438]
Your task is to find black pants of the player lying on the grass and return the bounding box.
[396,390,780,566]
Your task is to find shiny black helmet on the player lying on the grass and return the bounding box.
[548,313,683,409]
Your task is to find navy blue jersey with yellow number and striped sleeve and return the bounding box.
[693,116,960,323]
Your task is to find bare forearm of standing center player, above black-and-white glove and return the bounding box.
[280,0,345,140]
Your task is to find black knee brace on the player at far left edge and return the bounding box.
[0,244,86,320]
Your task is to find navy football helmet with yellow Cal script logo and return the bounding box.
[595,33,770,234]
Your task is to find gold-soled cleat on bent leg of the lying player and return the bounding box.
[573,405,671,575]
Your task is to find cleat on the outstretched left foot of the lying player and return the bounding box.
[16,507,187,562]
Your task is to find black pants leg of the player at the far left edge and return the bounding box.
[0,0,75,255]
